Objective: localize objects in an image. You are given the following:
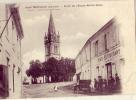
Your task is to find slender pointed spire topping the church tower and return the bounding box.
[48,10,56,34]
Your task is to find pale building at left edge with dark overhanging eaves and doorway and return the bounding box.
[0,4,24,98]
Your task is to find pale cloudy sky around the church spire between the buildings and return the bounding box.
[20,3,117,76]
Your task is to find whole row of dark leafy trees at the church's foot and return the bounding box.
[26,57,76,82]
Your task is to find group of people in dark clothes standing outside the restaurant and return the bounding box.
[94,73,121,91]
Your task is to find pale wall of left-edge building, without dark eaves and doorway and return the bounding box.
[0,4,22,98]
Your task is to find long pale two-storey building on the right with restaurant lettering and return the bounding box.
[75,18,125,88]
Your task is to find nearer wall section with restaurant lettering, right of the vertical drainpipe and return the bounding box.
[91,21,123,83]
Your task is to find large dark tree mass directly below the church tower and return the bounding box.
[43,57,76,82]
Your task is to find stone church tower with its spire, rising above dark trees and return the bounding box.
[44,12,60,61]
